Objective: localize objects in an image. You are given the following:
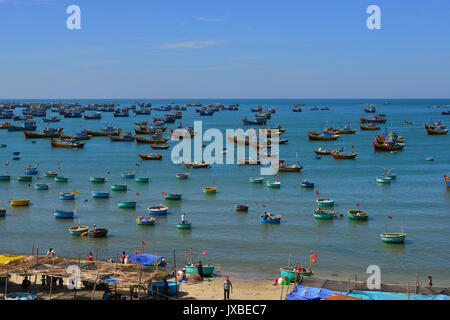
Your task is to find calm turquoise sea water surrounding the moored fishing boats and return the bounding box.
[0,99,450,286]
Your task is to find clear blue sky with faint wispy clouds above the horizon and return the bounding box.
[0,0,450,99]
